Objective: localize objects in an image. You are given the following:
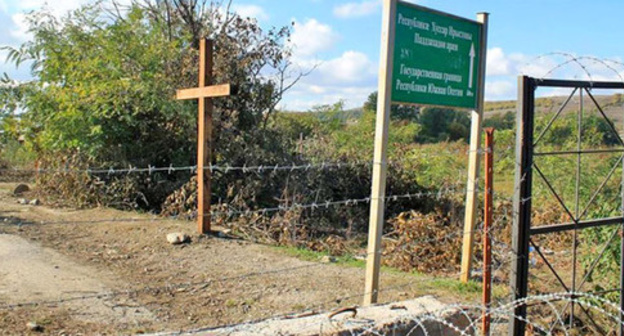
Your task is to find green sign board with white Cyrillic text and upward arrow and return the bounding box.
[392,1,481,108]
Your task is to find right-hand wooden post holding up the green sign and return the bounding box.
[461,13,489,283]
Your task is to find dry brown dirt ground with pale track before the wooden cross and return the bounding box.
[0,184,472,335]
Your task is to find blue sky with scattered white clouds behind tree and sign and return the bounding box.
[0,0,624,110]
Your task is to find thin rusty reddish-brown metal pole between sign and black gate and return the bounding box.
[482,128,494,336]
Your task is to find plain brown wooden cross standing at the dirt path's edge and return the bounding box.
[176,39,231,234]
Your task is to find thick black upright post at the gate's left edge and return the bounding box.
[509,76,535,336]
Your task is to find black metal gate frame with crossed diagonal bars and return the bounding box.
[509,76,624,336]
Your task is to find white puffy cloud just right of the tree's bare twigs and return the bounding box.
[290,19,338,58]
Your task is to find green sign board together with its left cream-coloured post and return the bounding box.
[364,0,486,305]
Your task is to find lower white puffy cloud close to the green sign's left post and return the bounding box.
[319,51,376,83]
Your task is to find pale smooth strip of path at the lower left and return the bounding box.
[0,234,153,324]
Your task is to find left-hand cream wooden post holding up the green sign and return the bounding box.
[364,0,397,305]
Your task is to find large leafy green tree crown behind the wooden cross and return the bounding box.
[0,0,301,166]
